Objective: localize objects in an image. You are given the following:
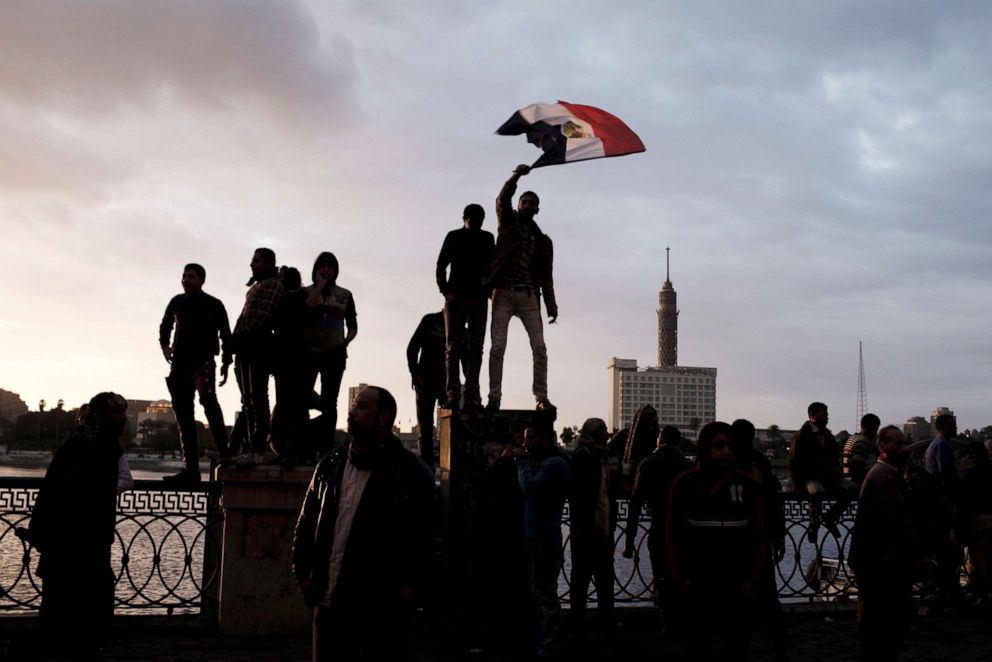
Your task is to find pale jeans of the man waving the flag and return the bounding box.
[489,289,548,402]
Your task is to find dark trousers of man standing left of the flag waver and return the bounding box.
[444,296,489,404]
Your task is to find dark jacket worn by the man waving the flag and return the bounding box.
[482,180,558,317]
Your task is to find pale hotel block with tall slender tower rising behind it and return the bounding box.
[607,253,716,434]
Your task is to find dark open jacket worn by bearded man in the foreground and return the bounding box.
[292,436,434,605]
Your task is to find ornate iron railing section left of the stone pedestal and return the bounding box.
[0,478,223,615]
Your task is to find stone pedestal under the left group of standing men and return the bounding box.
[216,466,313,636]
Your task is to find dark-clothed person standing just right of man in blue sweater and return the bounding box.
[568,418,616,636]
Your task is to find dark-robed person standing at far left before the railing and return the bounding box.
[28,393,127,659]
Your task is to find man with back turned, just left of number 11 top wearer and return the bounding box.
[622,425,690,631]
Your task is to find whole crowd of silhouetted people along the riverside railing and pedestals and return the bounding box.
[22,166,992,662]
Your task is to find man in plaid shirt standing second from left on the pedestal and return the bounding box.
[234,248,283,464]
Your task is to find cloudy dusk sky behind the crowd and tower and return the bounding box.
[0,0,992,431]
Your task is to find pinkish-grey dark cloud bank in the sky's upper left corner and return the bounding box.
[0,0,355,120]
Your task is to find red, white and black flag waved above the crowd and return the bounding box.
[496,101,644,168]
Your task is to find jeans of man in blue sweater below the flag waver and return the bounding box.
[524,540,562,659]
